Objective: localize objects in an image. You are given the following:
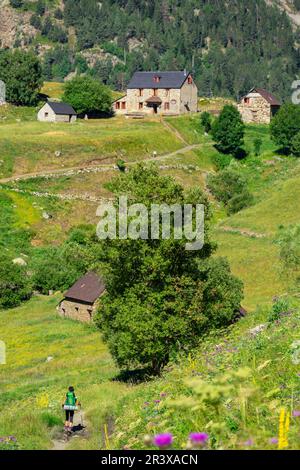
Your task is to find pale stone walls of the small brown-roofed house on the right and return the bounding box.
[238,93,271,124]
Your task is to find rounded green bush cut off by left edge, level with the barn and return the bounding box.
[0,257,32,309]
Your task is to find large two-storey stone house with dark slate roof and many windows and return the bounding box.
[113,71,198,116]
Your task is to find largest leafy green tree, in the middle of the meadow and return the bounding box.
[96,166,243,373]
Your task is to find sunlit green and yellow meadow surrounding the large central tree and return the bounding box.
[0,104,300,449]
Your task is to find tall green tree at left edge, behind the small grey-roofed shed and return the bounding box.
[0,50,43,106]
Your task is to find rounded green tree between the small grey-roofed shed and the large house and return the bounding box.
[63,76,112,114]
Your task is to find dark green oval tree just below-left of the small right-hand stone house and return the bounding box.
[212,105,245,155]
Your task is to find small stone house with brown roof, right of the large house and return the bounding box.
[238,88,281,124]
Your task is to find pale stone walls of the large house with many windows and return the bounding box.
[113,77,198,115]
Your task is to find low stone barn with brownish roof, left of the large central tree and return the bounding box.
[58,272,105,322]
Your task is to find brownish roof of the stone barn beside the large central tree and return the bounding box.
[65,272,105,304]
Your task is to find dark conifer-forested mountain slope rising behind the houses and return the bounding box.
[0,0,300,98]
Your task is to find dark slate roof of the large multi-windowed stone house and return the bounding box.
[127,72,190,90]
